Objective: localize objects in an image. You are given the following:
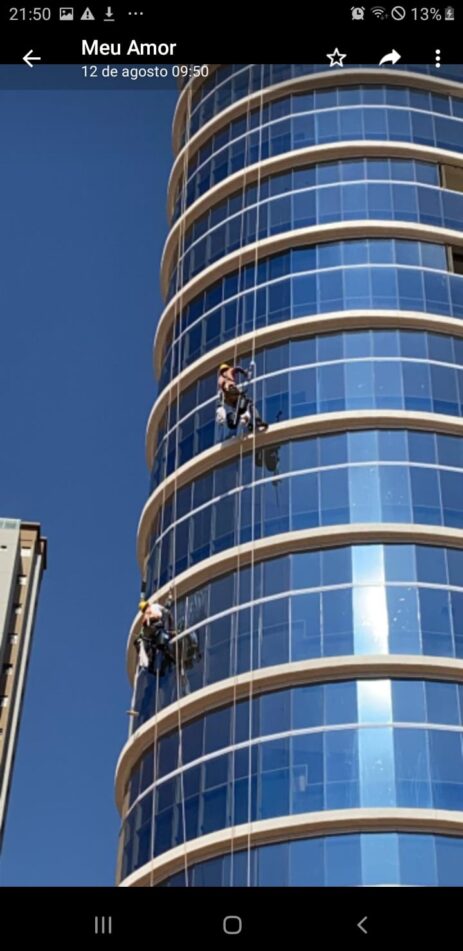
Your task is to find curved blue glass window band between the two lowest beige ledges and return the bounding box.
[120,679,463,874]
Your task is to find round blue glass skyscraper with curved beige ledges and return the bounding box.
[116,64,463,886]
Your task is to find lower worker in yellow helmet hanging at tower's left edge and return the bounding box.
[135,596,175,676]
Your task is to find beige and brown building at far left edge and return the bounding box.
[0,518,47,848]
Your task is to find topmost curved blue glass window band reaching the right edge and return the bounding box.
[173,86,463,221]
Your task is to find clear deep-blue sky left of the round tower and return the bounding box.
[0,78,176,885]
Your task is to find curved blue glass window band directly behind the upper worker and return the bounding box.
[148,330,463,491]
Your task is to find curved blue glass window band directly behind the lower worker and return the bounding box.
[124,535,463,730]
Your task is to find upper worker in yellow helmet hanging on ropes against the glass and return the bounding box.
[216,362,268,433]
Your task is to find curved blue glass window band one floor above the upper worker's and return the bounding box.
[160,238,463,389]
